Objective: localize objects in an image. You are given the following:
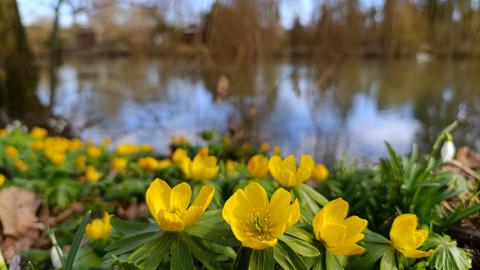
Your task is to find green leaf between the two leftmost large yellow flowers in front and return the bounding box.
[185,210,240,246]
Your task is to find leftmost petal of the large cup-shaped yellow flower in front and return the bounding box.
[145,178,172,218]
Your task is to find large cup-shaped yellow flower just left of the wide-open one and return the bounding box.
[145,178,215,232]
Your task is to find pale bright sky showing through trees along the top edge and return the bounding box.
[17,0,381,28]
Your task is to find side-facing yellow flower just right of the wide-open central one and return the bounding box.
[312,198,368,256]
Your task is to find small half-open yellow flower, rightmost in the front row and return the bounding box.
[390,214,433,258]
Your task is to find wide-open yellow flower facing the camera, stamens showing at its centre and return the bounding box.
[222,182,300,249]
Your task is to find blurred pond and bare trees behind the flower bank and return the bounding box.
[0,0,480,162]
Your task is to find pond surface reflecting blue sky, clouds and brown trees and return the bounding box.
[37,59,480,160]
